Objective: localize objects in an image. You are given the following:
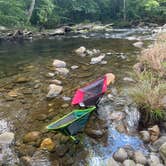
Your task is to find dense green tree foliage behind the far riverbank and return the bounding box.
[0,0,166,28]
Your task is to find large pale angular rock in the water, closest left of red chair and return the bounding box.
[47,84,63,99]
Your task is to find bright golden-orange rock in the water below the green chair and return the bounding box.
[40,138,55,151]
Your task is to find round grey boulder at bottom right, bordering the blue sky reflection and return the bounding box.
[113,148,128,162]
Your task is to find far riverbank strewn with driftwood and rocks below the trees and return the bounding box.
[0,23,166,41]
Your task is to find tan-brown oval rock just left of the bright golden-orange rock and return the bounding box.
[23,131,41,143]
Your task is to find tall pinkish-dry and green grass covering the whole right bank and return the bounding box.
[128,33,166,126]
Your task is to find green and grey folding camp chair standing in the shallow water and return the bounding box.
[46,107,96,142]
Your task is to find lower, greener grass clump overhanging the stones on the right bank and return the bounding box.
[128,71,166,124]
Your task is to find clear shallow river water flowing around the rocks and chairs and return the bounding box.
[0,29,154,166]
